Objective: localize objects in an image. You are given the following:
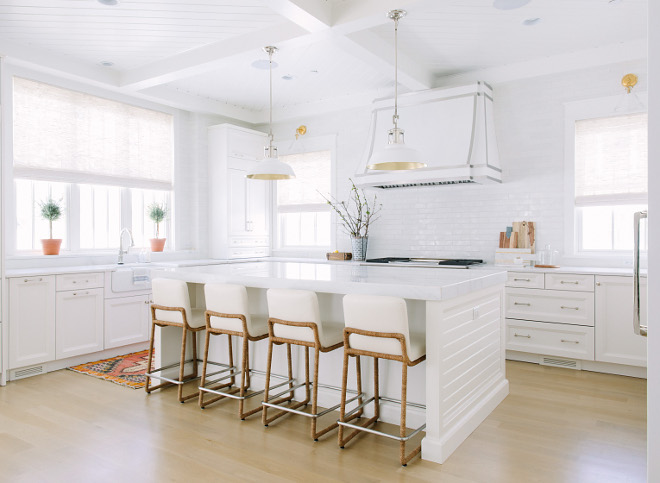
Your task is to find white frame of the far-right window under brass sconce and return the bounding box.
[564,92,648,263]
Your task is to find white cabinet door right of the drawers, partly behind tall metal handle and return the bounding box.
[596,276,647,367]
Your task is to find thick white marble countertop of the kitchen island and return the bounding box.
[152,261,506,300]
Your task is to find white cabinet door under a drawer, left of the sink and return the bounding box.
[55,288,103,359]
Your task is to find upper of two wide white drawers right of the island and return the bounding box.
[506,288,594,326]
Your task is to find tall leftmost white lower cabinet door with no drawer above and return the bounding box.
[9,275,55,369]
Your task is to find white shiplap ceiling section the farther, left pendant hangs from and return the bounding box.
[164,42,393,111]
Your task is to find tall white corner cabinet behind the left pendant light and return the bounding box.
[209,124,272,258]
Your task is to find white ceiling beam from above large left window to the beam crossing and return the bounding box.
[120,21,306,90]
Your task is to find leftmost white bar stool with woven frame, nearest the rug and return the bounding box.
[145,278,206,403]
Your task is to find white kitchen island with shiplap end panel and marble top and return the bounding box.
[153,261,509,463]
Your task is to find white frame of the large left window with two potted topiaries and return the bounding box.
[0,67,182,258]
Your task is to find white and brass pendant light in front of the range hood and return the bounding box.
[367,10,426,171]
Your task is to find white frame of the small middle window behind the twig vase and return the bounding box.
[270,134,337,256]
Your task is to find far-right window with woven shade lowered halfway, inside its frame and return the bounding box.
[574,113,648,253]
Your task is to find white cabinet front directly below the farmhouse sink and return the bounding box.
[104,295,151,349]
